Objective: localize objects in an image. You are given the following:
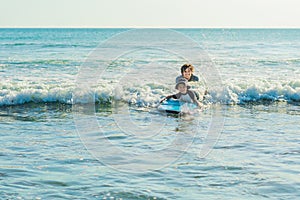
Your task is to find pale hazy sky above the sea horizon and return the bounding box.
[0,0,300,28]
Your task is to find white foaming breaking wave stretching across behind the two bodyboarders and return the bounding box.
[0,81,300,107]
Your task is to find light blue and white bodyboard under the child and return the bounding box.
[158,99,197,114]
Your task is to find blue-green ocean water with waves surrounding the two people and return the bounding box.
[0,28,300,200]
